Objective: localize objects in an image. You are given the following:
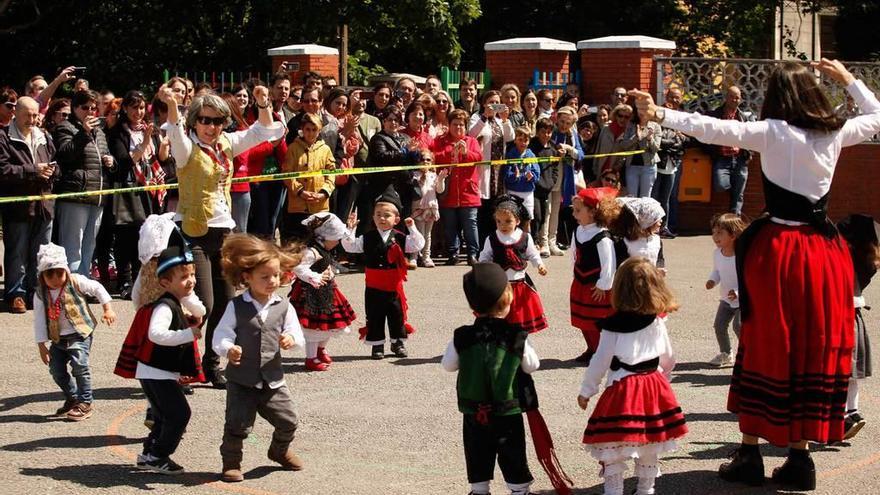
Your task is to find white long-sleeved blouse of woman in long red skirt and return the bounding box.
[663,80,880,203]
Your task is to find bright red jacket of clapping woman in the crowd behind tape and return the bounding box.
[431,133,483,208]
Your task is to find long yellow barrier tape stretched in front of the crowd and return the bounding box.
[0,150,644,204]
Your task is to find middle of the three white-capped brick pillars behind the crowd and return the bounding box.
[484,38,576,91]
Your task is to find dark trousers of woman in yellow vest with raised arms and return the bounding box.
[187,227,235,381]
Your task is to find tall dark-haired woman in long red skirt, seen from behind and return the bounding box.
[631,59,880,490]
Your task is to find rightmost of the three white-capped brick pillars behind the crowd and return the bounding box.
[577,36,675,105]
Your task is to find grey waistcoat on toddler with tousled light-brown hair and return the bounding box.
[226,295,288,387]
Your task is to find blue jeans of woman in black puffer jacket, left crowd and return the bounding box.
[55,201,104,277]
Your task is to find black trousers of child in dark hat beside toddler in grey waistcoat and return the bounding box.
[140,380,191,457]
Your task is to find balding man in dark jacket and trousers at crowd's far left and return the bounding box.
[0,96,60,314]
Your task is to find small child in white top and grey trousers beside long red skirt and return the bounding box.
[706,213,746,368]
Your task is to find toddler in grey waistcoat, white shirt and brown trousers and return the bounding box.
[212,234,305,483]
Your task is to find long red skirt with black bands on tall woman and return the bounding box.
[727,223,855,447]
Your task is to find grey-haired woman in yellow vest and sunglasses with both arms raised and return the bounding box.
[159,85,285,388]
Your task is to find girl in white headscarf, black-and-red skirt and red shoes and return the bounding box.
[290,213,356,371]
